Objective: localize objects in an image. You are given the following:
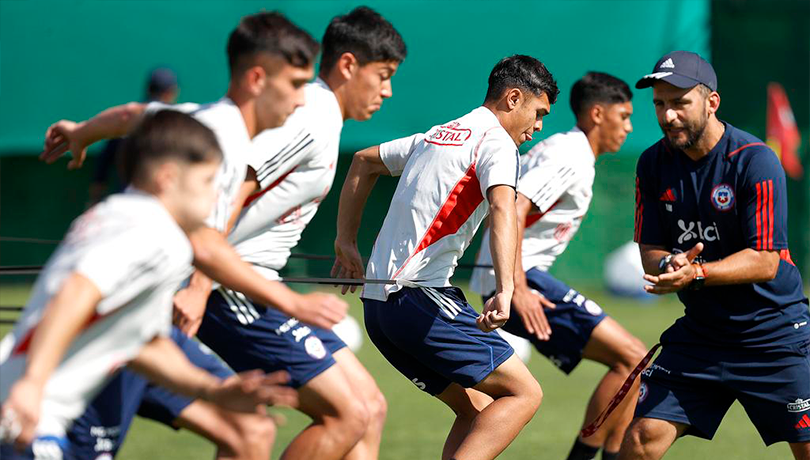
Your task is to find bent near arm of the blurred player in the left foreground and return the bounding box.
[0,273,102,446]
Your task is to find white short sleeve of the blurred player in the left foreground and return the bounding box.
[75,229,169,297]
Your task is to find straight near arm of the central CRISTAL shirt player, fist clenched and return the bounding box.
[477,185,517,332]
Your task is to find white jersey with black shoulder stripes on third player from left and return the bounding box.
[228,79,343,280]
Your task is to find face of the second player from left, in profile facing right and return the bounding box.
[256,61,314,132]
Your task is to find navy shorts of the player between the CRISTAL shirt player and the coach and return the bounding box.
[483,268,607,374]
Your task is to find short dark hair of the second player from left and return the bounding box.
[228,11,318,75]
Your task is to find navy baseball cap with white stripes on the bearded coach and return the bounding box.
[636,51,717,91]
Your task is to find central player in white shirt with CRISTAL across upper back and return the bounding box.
[333,55,558,460]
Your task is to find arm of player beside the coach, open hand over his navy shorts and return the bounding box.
[512,192,555,340]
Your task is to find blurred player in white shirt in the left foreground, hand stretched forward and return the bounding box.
[0,111,295,459]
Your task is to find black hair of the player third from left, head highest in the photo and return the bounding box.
[321,6,408,72]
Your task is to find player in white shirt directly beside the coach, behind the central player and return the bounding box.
[470,72,646,460]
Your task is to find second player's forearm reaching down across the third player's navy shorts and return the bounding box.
[189,227,349,329]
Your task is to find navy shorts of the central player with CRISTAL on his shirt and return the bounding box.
[363,287,514,395]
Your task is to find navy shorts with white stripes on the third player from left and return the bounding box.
[197,288,346,388]
